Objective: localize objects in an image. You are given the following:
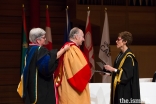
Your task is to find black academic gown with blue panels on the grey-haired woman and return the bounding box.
[24,46,58,104]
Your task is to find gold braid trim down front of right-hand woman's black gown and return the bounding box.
[113,52,134,99]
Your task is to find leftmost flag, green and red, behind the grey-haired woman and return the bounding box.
[20,5,28,74]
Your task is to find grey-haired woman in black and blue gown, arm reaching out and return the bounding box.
[22,28,69,104]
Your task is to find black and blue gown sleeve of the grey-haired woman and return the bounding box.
[37,47,58,77]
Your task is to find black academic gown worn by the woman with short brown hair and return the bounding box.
[111,49,141,104]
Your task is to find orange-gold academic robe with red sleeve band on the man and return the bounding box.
[55,43,91,104]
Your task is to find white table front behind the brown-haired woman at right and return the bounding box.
[89,78,156,104]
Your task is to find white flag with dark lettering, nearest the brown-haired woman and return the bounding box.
[99,11,112,83]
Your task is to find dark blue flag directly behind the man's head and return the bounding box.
[64,6,71,43]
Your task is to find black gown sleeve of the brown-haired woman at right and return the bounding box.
[120,56,133,84]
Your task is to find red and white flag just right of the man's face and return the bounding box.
[84,11,95,75]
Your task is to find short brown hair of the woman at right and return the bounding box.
[118,31,133,46]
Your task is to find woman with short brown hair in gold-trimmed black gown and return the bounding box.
[104,31,141,104]
